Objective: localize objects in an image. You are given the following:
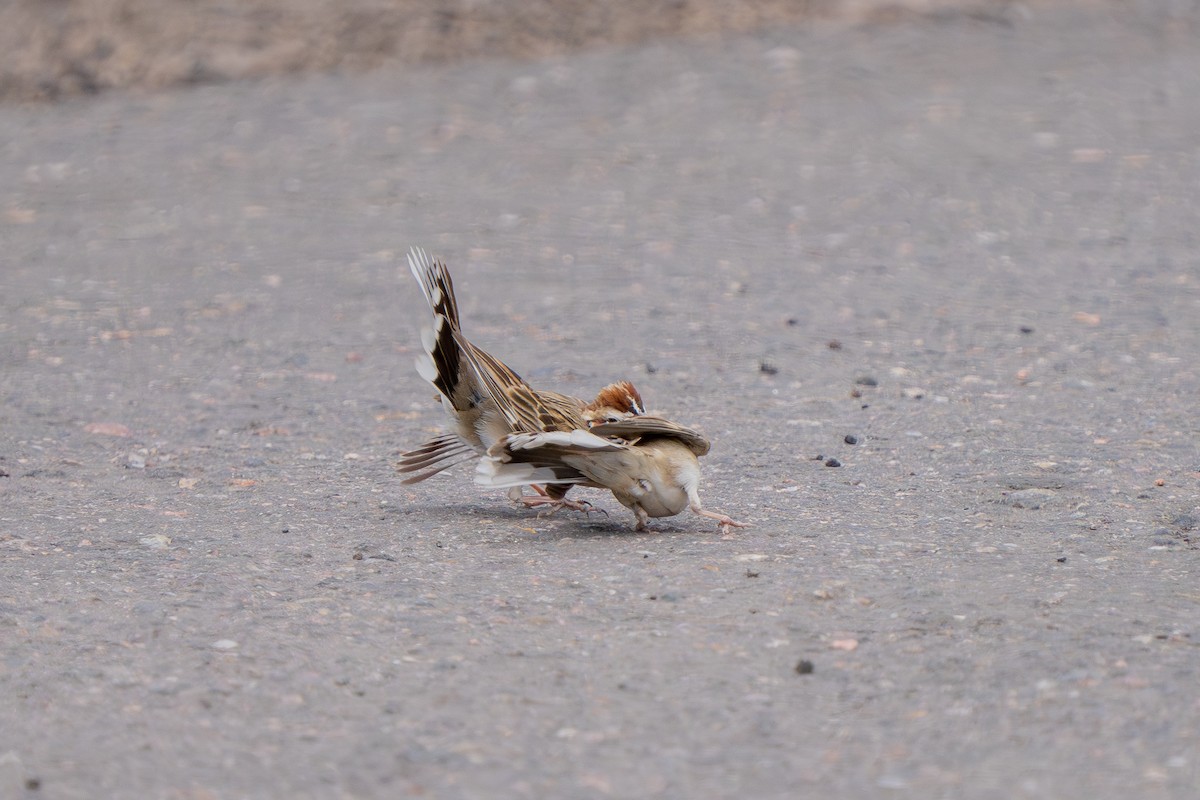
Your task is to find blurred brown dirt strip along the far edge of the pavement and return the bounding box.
[0,0,1027,101]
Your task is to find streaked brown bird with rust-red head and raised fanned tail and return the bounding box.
[396,247,644,511]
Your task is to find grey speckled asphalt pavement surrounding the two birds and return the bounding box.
[0,4,1200,800]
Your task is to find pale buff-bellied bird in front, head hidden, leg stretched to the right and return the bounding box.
[475,415,748,533]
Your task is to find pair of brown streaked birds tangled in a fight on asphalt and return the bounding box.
[397,247,745,530]
